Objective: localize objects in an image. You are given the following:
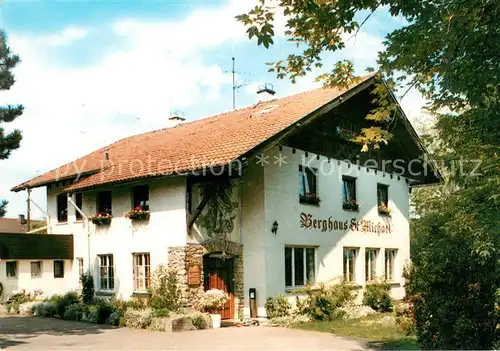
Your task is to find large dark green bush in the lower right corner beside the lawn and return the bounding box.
[404,214,500,350]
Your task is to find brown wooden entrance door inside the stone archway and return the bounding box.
[203,256,234,319]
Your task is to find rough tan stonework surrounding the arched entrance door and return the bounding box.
[168,240,244,319]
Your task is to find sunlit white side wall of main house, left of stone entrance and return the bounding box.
[47,177,186,299]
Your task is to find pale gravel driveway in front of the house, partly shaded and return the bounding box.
[0,316,365,350]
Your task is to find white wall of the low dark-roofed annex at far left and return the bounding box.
[0,260,76,298]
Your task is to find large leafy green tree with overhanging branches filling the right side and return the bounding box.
[237,0,500,349]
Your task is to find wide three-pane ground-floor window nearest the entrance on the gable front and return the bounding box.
[285,246,316,288]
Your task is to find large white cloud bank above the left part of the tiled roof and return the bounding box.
[0,0,258,217]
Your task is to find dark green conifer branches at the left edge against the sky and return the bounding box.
[0,31,23,217]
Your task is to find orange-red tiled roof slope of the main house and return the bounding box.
[12,74,375,191]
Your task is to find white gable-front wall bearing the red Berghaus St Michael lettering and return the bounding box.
[264,147,410,298]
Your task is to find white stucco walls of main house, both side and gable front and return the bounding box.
[40,147,409,316]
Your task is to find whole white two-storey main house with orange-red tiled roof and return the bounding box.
[13,75,440,318]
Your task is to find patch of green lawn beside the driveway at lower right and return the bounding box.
[293,313,419,350]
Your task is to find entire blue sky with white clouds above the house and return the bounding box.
[0,0,423,217]
